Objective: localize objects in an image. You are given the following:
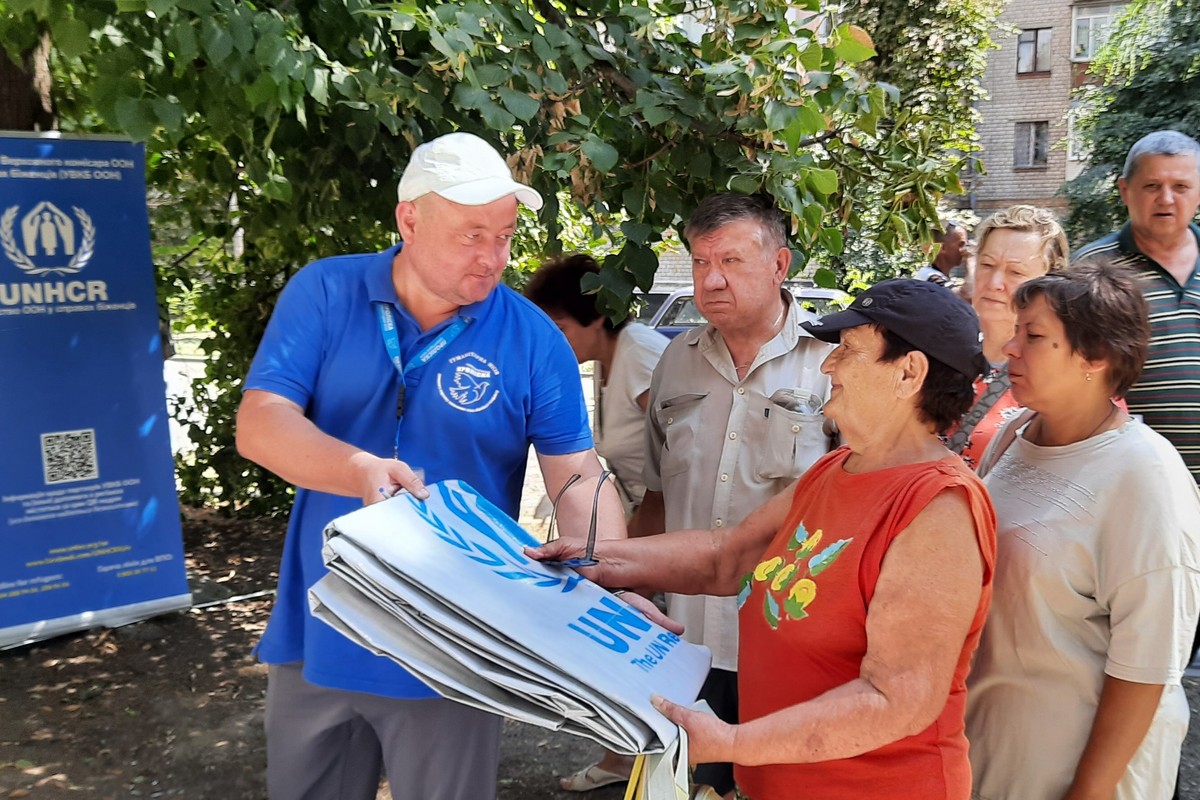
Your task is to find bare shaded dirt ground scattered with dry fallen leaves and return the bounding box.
[0,511,1200,800]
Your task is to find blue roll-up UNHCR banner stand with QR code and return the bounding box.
[0,134,192,648]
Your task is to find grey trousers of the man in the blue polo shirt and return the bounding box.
[266,663,504,800]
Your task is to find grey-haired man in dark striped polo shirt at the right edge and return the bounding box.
[1074,131,1200,799]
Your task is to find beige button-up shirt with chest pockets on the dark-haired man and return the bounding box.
[644,296,833,670]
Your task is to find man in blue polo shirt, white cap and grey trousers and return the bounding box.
[238,133,624,800]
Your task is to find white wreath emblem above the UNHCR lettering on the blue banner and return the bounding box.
[0,200,96,276]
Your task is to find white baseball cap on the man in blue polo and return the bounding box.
[396,132,541,211]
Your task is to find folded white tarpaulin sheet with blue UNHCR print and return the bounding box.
[308,481,712,753]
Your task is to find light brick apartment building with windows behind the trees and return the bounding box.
[964,0,1124,215]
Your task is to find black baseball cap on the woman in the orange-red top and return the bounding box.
[800,278,988,378]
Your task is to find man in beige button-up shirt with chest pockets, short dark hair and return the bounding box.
[630,193,832,795]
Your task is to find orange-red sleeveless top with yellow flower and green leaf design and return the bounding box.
[734,447,996,800]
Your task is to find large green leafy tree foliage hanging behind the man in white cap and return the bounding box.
[14,0,998,509]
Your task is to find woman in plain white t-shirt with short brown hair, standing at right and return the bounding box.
[966,264,1200,800]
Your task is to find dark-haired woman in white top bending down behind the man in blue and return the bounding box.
[524,253,668,792]
